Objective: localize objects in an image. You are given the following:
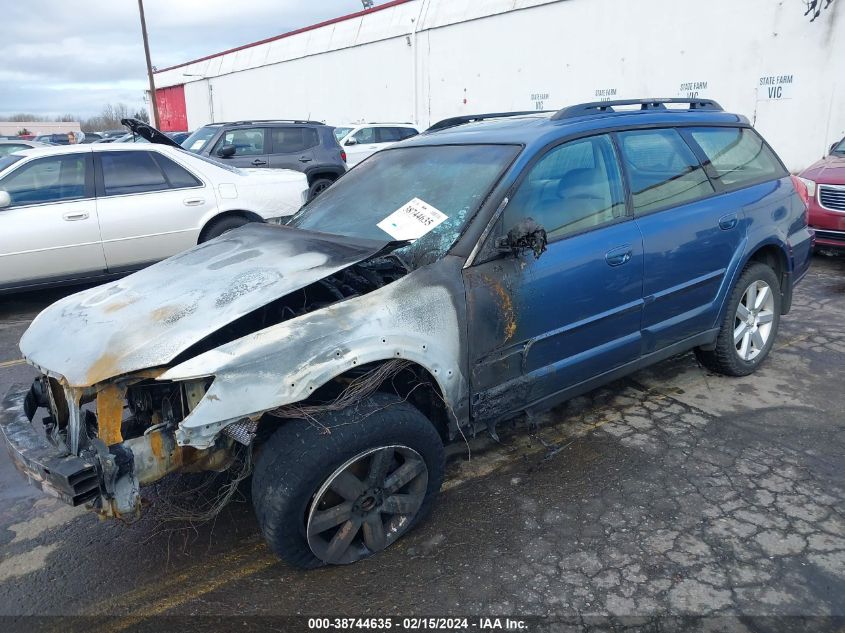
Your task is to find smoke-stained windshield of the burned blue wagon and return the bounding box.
[288,145,520,268]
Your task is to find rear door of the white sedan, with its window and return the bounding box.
[94,150,217,271]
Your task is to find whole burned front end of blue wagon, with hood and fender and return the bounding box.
[0,225,466,520]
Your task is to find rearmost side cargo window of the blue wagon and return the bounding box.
[690,128,784,190]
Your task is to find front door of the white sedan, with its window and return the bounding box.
[0,151,106,287]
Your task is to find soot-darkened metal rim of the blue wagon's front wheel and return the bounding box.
[306,445,428,565]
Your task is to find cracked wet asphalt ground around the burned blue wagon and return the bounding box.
[0,256,845,631]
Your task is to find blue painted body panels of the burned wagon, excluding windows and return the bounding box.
[412,110,812,423]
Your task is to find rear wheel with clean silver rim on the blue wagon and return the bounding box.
[695,262,781,376]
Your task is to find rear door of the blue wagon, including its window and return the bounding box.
[618,128,746,354]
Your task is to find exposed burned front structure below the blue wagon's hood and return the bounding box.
[0,372,235,520]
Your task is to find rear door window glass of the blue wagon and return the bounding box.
[619,129,715,213]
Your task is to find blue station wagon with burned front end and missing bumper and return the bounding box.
[0,99,813,567]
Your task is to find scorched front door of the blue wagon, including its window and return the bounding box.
[465,135,643,418]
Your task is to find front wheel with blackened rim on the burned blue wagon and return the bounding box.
[252,394,445,569]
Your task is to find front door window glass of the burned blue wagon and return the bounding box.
[504,135,625,242]
